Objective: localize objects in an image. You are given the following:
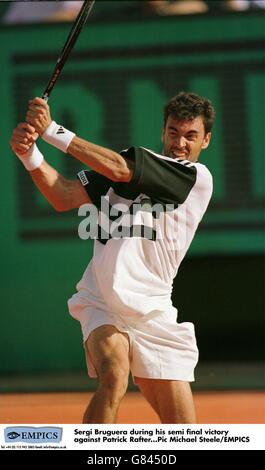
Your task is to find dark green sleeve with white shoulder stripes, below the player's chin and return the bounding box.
[121,147,197,204]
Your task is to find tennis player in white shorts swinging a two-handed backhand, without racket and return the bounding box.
[11,92,214,423]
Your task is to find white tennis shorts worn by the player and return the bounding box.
[68,280,198,382]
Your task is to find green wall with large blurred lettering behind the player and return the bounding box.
[0,12,265,380]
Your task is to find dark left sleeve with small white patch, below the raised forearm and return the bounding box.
[77,170,113,209]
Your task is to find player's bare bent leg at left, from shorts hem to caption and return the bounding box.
[83,325,130,423]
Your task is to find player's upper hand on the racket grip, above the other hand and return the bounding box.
[26,98,52,135]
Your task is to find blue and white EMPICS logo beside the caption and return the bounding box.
[4,426,63,444]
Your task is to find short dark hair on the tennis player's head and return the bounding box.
[164,91,215,133]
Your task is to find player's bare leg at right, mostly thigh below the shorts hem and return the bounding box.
[134,377,196,424]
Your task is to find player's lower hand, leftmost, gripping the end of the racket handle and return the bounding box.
[10,122,38,155]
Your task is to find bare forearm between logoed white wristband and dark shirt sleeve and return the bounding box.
[67,136,132,182]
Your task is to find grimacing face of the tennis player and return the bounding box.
[162,116,211,162]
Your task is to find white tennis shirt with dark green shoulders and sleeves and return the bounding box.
[77,147,212,315]
